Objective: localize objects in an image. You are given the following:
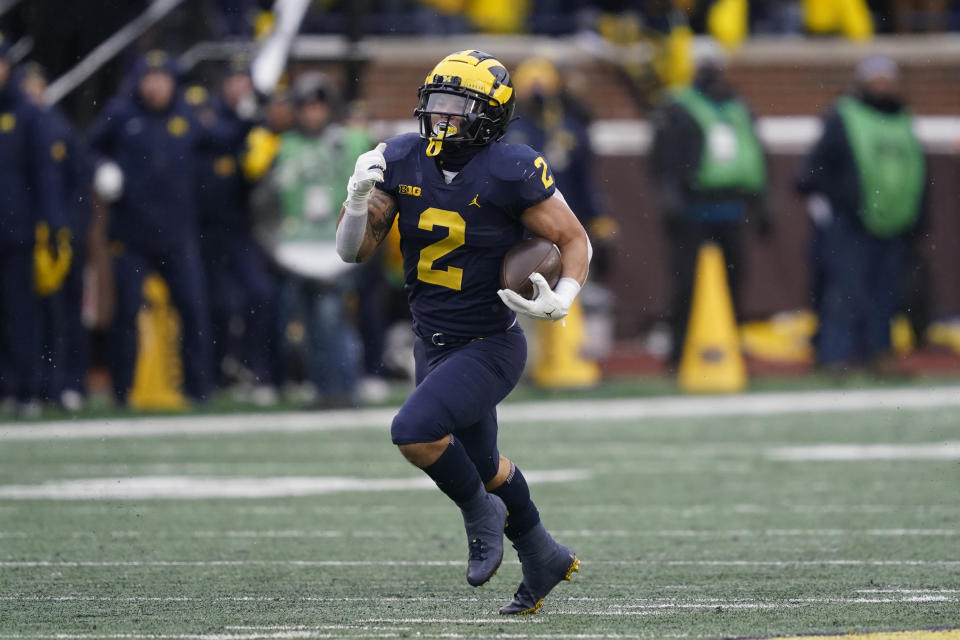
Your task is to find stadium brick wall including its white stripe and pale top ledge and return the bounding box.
[344,36,960,337]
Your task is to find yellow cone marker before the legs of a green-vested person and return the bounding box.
[678,242,747,393]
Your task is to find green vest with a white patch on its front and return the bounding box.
[672,87,767,194]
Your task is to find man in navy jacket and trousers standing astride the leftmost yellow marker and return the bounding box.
[90,51,246,404]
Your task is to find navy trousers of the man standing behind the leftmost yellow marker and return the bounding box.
[110,242,212,404]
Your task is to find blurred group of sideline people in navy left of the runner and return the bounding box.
[0,41,420,415]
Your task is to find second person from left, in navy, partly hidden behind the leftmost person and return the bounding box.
[21,63,90,410]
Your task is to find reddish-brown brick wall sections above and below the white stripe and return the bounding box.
[338,40,960,337]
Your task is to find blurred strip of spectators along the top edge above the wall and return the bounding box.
[165,0,960,36]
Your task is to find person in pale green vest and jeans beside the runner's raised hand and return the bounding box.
[259,73,371,406]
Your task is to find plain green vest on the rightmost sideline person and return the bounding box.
[837,98,924,237]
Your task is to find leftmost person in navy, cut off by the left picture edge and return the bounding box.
[0,35,71,416]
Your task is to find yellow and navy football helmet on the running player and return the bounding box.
[413,50,516,156]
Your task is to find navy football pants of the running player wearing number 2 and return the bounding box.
[390,325,527,482]
